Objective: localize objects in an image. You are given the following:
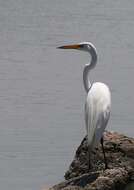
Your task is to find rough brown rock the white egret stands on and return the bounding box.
[50,132,134,190]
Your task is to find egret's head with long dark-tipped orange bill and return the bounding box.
[57,42,96,53]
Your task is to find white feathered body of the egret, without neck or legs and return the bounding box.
[85,82,111,148]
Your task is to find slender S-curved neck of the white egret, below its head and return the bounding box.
[83,48,97,93]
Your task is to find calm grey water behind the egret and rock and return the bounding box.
[0,0,134,190]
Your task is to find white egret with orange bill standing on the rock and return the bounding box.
[57,42,111,170]
